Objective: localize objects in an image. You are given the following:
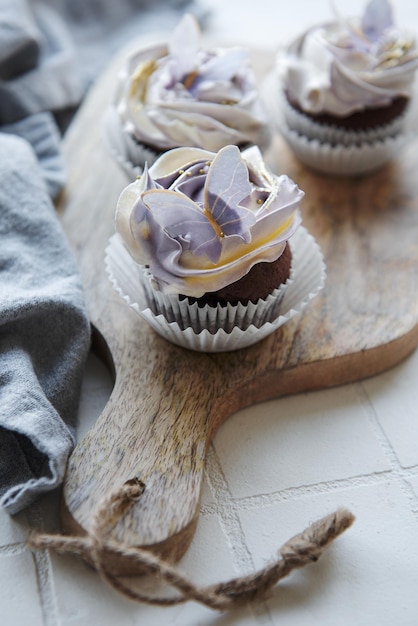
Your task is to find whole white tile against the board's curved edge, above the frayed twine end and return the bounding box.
[214,386,389,498]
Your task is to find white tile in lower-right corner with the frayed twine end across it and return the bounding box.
[239,480,418,626]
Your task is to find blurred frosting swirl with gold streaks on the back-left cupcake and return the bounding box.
[104,14,269,177]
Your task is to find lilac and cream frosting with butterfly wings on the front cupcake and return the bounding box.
[116,145,304,298]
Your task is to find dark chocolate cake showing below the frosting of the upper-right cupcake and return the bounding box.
[286,92,409,130]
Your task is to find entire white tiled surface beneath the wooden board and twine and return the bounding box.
[4,0,418,626]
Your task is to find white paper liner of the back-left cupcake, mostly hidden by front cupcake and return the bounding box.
[102,106,161,180]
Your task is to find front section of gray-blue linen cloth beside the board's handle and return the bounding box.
[0,133,89,513]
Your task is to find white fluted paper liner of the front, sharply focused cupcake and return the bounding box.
[105,226,326,352]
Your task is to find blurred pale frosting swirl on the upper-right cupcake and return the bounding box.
[279,0,418,117]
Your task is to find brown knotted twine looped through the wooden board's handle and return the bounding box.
[29,480,354,611]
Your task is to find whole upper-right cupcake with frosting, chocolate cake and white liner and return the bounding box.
[267,0,418,174]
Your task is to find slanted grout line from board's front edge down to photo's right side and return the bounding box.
[355,381,418,520]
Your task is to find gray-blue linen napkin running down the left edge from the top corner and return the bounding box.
[0,0,90,513]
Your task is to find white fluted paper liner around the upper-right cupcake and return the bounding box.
[263,72,416,176]
